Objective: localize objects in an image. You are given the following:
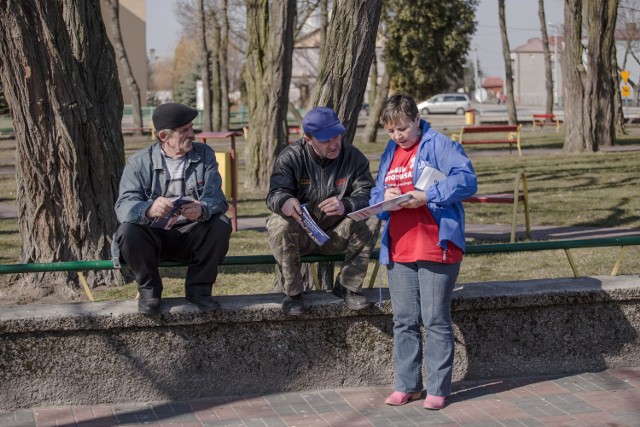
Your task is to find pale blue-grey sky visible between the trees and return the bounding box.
[147,0,564,77]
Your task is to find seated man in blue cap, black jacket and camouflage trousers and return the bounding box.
[267,107,379,315]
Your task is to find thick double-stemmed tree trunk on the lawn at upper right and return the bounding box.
[562,0,617,153]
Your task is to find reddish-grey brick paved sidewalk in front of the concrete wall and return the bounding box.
[0,368,640,427]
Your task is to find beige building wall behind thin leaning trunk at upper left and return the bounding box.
[100,0,147,106]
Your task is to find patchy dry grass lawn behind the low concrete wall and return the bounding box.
[0,128,640,300]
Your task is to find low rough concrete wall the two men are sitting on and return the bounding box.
[0,275,640,411]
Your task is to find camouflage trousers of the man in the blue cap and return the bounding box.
[267,214,380,295]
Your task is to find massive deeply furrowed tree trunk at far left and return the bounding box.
[0,0,124,295]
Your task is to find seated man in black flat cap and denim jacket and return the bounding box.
[112,103,231,314]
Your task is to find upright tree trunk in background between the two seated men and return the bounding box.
[244,0,296,191]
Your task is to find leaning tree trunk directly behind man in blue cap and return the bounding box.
[310,0,382,144]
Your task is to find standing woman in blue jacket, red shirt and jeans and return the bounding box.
[370,94,477,409]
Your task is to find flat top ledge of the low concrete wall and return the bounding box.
[0,275,640,334]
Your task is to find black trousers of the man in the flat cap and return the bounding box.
[115,214,231,298]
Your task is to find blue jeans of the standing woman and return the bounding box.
[387,261,460,396]
